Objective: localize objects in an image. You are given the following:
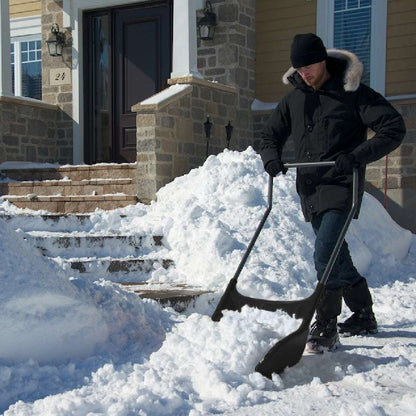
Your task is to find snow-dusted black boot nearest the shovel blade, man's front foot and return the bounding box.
[306,289,342,353]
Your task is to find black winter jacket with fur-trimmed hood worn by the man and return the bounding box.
[259,49,406,221]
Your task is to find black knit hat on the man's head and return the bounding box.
[290,33,328,68]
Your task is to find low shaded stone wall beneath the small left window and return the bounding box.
[0,97,65,163]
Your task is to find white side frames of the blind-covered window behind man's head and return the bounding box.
[316,0,387,95]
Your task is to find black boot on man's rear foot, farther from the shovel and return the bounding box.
[338,278,377,336]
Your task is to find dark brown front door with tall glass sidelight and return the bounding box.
[83,0,172,163]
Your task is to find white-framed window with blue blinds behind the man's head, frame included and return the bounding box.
[317,0,387,94]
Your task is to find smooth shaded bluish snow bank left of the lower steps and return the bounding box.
[0,221,169,364]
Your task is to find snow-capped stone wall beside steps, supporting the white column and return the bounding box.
[132,77,237,202]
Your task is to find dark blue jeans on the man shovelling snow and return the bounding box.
[312,211,363,290]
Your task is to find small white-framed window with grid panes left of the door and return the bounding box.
[10,37,42,100]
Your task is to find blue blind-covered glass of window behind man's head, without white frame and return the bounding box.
[333,0,372,85]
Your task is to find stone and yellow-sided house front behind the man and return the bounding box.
[0,0,416,232]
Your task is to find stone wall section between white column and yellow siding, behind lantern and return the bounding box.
[198,0,256,150]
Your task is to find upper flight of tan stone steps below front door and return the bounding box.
[0,163,140,214]
